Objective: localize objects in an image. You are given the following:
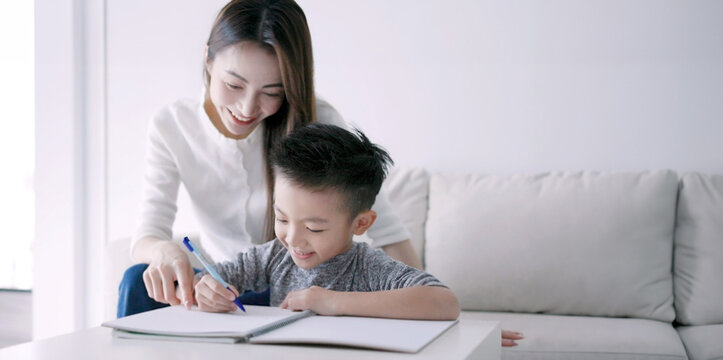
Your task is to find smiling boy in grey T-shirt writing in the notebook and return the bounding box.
[188,124,459,320]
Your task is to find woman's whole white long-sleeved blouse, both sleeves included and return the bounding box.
[131,94,410,261]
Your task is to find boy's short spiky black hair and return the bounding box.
[269,123,394,218]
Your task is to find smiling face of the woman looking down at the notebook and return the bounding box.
[206,41,284,139]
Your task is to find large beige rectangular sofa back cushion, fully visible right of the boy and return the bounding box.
[425,170,677,321]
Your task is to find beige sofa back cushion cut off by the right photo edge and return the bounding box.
[673,173,723,326]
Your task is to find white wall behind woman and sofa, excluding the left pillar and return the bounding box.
[107,0,723,256]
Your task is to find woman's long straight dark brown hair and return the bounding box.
[204,0,316,240]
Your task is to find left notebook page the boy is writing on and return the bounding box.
[102,305,299,337]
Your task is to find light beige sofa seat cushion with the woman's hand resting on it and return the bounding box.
[460,311,686,360]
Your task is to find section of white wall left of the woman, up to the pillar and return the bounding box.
[106,0,226,239]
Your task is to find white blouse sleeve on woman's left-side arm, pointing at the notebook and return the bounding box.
[131,110,180,251]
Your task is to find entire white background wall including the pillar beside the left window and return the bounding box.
[33,0,723,337]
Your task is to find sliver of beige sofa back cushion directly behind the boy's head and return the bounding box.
[383,167,429,261]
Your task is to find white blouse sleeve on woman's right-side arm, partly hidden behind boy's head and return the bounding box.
[316,100,412,247]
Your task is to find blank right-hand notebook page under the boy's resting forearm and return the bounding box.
[249,315,457,353]
